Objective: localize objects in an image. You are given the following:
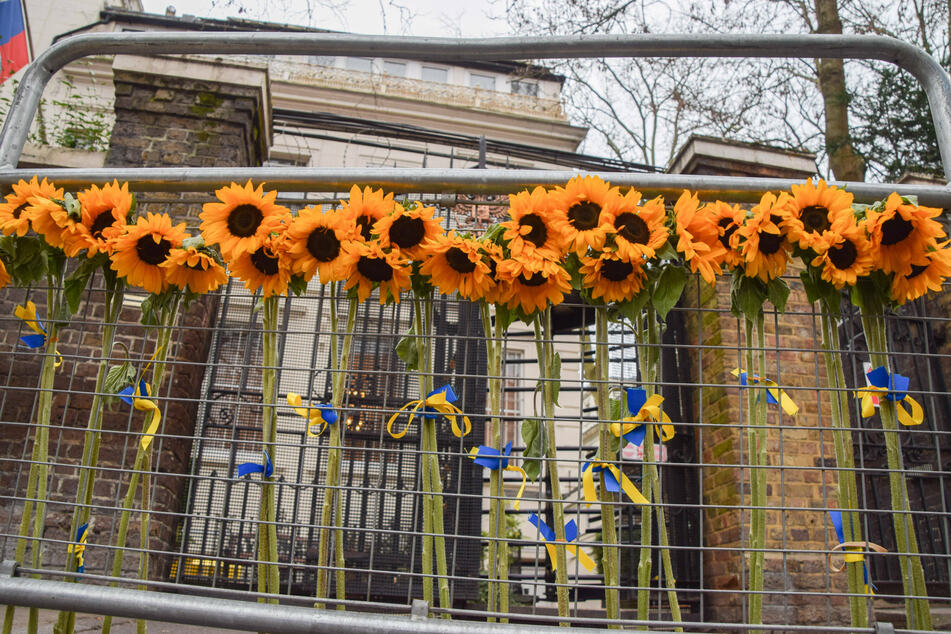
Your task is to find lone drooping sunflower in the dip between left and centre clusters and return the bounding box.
[419,231,494,301]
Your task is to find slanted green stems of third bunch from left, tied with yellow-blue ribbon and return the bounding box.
[102,293,181,634]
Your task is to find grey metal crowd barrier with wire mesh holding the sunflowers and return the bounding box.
[0,33,951,632]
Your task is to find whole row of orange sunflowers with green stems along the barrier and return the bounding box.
[0,176,951,628]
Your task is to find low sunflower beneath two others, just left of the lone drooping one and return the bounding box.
[344,241,412,304]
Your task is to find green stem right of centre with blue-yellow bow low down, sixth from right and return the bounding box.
[535,308,570,627]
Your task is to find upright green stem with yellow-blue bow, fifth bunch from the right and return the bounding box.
[594,306,621,629]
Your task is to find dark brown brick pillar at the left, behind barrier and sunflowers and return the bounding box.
[0,61,266,577]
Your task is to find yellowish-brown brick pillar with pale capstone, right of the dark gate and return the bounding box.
[671,137,848,625]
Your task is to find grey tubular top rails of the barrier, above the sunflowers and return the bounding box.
[0,32,951,202]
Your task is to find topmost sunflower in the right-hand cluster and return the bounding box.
[784,179,853,253]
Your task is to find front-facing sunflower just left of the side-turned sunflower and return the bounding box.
[601,189,669,259]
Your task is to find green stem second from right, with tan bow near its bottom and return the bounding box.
[821,300,868,628]
